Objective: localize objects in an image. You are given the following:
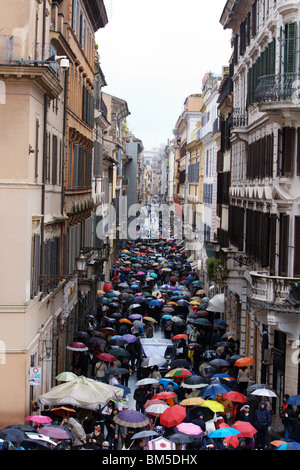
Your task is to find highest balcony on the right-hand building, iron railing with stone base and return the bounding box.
[254,72,300,126]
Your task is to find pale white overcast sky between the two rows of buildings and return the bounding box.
[96,0,231,150]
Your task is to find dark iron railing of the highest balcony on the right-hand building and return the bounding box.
[254,72,300,103]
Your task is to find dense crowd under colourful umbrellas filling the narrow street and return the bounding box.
[3,240,300,450]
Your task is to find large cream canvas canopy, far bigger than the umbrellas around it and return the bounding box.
[39,376,124,410]
